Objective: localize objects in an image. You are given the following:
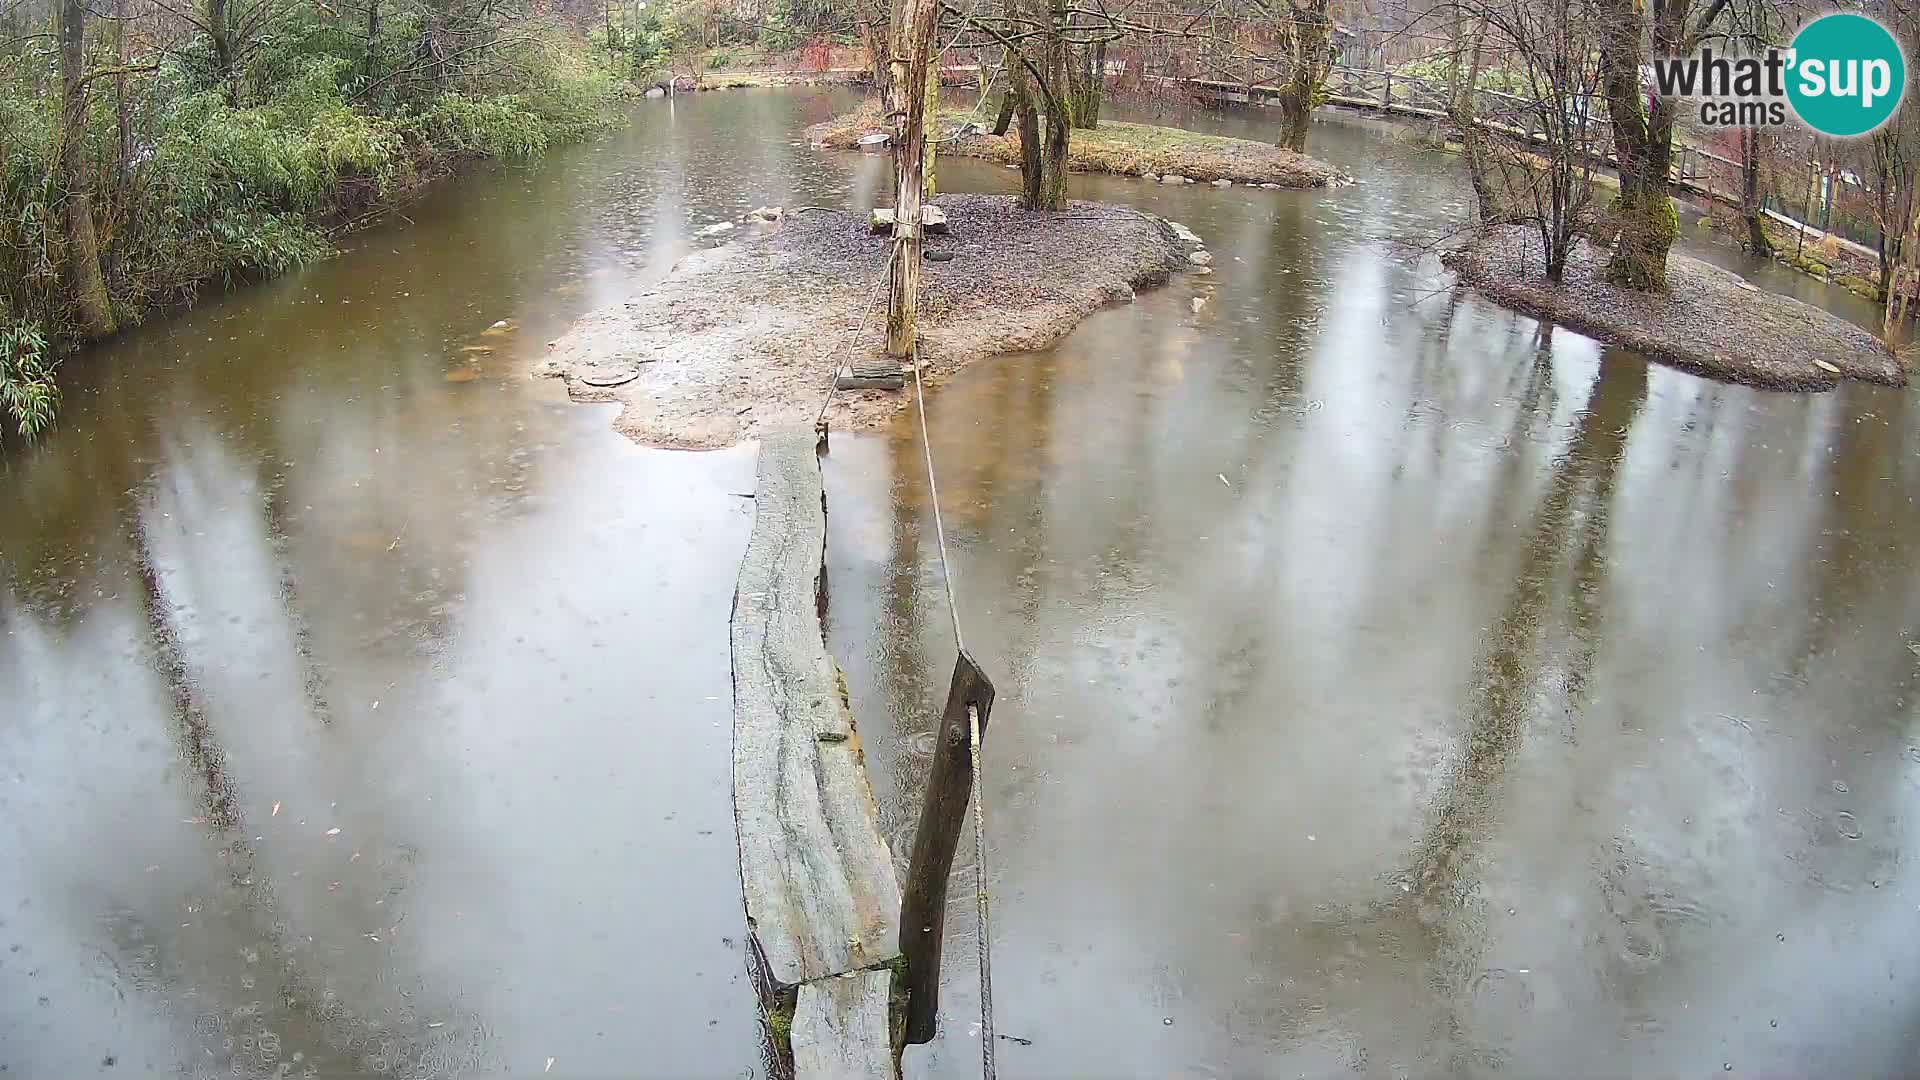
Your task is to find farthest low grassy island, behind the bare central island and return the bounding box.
[806,102,1346,188]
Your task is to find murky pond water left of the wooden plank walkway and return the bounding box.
[0,92,890,1076]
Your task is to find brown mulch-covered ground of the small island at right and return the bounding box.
[1442,225,1907,390]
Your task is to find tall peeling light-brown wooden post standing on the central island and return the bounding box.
[887,0,939,359]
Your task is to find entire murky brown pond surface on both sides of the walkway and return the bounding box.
[0,90,1920,1076]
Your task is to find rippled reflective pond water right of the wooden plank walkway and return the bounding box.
[826,102,1920,1076]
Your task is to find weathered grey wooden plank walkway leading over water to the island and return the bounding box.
[732,432,900,1080]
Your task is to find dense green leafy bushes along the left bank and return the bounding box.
[0,14,614,434]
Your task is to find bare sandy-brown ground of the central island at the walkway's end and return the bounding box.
[536,196,1196,448]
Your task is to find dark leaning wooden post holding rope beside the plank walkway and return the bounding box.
[900,651,993,1043]
